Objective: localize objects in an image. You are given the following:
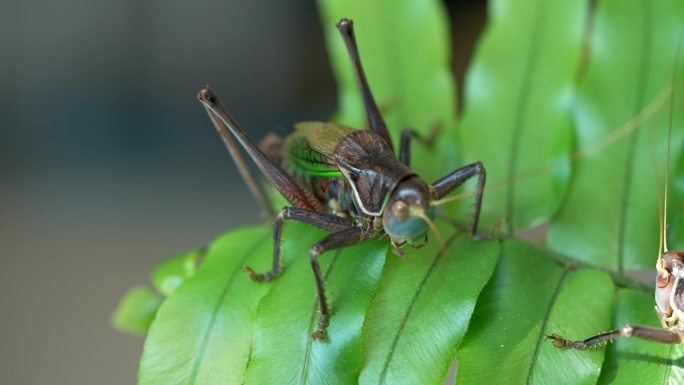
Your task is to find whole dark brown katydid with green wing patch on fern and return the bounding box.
[198,19,486,339]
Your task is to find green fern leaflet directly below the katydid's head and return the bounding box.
[359,227,499,385]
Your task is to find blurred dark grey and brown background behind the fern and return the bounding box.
[0,0,486,385]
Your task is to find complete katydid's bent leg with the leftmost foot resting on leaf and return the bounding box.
[244,207,351,282]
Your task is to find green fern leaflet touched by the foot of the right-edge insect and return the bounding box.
[457,240,614,385]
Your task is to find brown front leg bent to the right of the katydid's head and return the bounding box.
[432,162,487,237]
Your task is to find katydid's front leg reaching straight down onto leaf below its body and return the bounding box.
[311,227,371,339]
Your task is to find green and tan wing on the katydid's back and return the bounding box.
[285,122,355,177]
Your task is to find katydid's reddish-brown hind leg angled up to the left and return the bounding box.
[197,86,325,211]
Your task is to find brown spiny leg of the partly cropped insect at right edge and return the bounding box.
[546,325,682,350]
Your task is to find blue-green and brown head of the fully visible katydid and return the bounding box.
[382,176,440,246]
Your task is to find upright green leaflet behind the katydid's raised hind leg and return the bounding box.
[318,0,456,180]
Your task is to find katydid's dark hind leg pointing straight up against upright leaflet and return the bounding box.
[337,19,394,149]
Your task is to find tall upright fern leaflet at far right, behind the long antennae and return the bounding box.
[548,0,684,272]
